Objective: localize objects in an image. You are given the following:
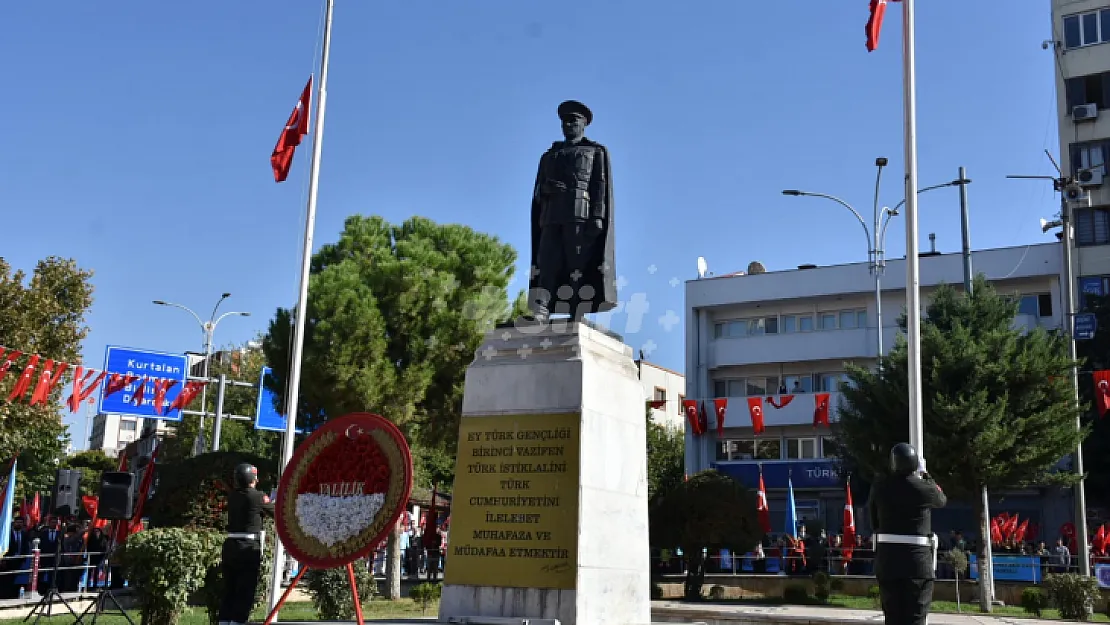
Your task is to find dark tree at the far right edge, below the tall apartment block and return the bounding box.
[1068,294,1110,506]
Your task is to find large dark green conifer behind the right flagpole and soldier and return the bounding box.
[835,275,1086,608]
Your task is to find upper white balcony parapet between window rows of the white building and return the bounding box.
[707,326,900,369]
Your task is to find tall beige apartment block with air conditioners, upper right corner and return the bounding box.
[1046,0,1110,293]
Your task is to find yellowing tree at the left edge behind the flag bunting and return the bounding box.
[0,256,92,497]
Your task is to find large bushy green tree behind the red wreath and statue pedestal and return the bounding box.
[263,215,522,486]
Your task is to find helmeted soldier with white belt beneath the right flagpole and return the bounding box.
[869,443,948,625]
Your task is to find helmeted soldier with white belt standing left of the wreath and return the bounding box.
[219,464,274,625]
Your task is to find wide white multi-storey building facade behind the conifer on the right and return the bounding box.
[686,243,1070,535]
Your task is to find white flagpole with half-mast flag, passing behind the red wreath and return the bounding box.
[270,0,335,609]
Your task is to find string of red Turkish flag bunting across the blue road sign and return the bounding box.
[0,345,208,415]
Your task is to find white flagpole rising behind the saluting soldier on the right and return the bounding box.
[902,0,925,461]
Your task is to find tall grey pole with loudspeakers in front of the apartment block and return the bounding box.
[1041,214,1091,576]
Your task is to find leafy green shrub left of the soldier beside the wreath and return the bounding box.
[119,527,223,625]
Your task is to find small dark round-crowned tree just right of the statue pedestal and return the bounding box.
[648,470,763,601]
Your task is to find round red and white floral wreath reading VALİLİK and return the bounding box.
[275,413,413,568]
